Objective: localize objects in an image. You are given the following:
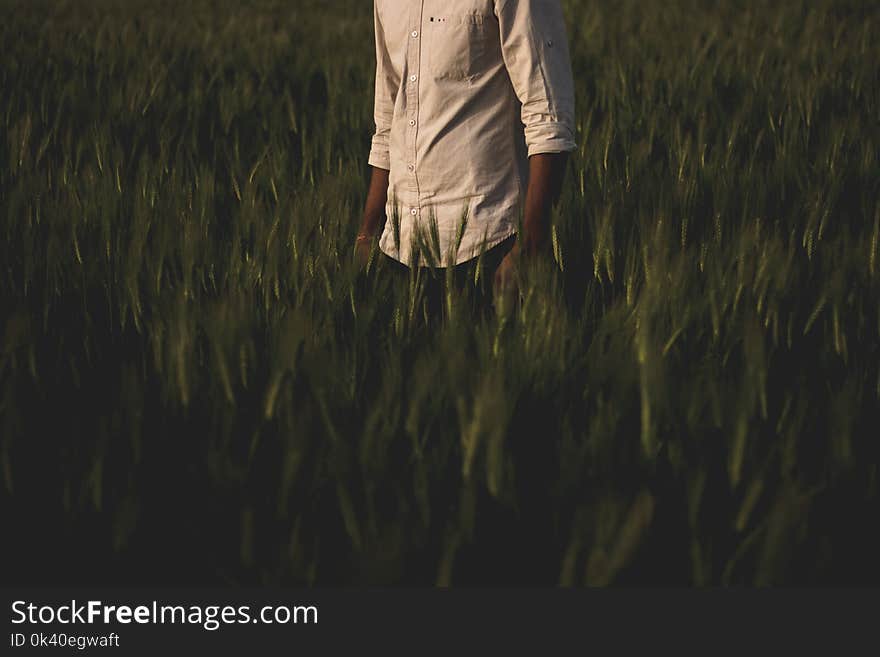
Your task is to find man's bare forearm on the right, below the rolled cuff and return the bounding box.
[517,153,568,255]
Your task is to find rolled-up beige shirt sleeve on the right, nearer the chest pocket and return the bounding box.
[495,0,576,156]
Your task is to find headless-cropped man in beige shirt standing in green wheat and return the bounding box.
[356,0,575,316]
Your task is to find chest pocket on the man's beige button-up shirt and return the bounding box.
[426,12,491,80]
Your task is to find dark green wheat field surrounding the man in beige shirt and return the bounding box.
[0,0,880,586]
